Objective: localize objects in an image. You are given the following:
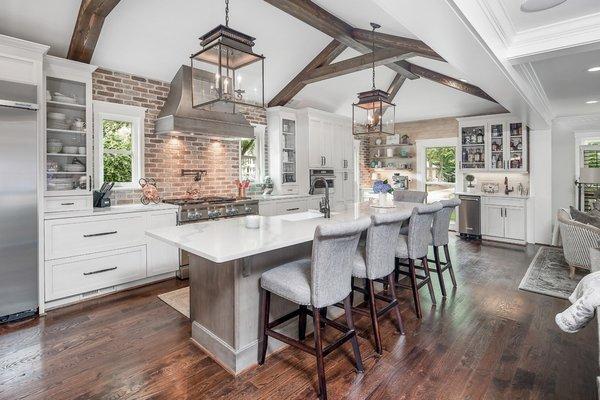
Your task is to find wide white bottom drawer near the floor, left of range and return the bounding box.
[45,246,146,301]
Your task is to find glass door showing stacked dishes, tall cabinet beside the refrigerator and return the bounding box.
[45,77,91,194]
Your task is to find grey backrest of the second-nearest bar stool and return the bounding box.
[365,212,410,279]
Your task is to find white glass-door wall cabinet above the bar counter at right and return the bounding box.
[457,114,528,172]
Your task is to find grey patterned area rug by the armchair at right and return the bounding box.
[519,247,585,299]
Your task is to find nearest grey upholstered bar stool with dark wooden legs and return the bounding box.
[258,218,371,399]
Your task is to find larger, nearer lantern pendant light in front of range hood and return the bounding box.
[190,0,265,113]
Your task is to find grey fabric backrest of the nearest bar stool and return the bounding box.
[310,217,371,308]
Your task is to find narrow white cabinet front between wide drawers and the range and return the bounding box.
[146,212,179,276]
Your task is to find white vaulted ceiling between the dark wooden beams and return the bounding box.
[0,0,501,121]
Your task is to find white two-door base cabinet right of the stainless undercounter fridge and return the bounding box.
[481,196,527,243]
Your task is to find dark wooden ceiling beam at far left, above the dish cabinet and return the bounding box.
[67,0,120,64]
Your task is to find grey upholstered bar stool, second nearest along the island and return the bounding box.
[352,212,408,354]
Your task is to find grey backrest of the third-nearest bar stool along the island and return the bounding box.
[408,201,442,260]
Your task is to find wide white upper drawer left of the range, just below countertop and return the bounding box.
[45,214,146,260]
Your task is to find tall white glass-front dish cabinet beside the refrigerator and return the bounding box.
[43,56,96,212]
